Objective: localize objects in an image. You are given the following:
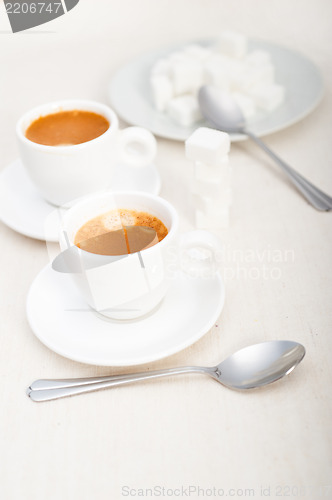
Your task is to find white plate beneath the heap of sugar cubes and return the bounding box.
[108,40,323,141]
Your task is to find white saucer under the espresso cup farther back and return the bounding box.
[0,160,161,242]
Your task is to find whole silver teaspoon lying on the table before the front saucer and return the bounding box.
[27,340,305,402]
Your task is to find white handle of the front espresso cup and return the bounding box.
[179,230,222,277]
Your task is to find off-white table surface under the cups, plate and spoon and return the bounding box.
[0,0,332,500]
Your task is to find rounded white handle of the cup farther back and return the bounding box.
[118,127,157,167]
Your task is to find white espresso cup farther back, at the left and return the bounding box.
[16,100,157,206]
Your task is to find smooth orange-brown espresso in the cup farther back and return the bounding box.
[25,110,110,146]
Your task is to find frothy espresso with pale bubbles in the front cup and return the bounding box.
[74,209,168,255]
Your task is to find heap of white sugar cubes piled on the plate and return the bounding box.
[150,31,285,127]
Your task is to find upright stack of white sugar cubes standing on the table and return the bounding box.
[185,127,232,230]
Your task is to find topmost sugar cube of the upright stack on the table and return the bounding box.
[185,127,230,167]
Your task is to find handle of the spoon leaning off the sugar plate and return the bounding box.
[243,130,332,211]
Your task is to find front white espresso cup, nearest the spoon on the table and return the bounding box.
[58,191,220,320]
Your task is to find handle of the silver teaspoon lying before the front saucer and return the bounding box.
[27,366,213,402]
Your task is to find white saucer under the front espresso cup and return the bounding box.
[27,265,225,366]
